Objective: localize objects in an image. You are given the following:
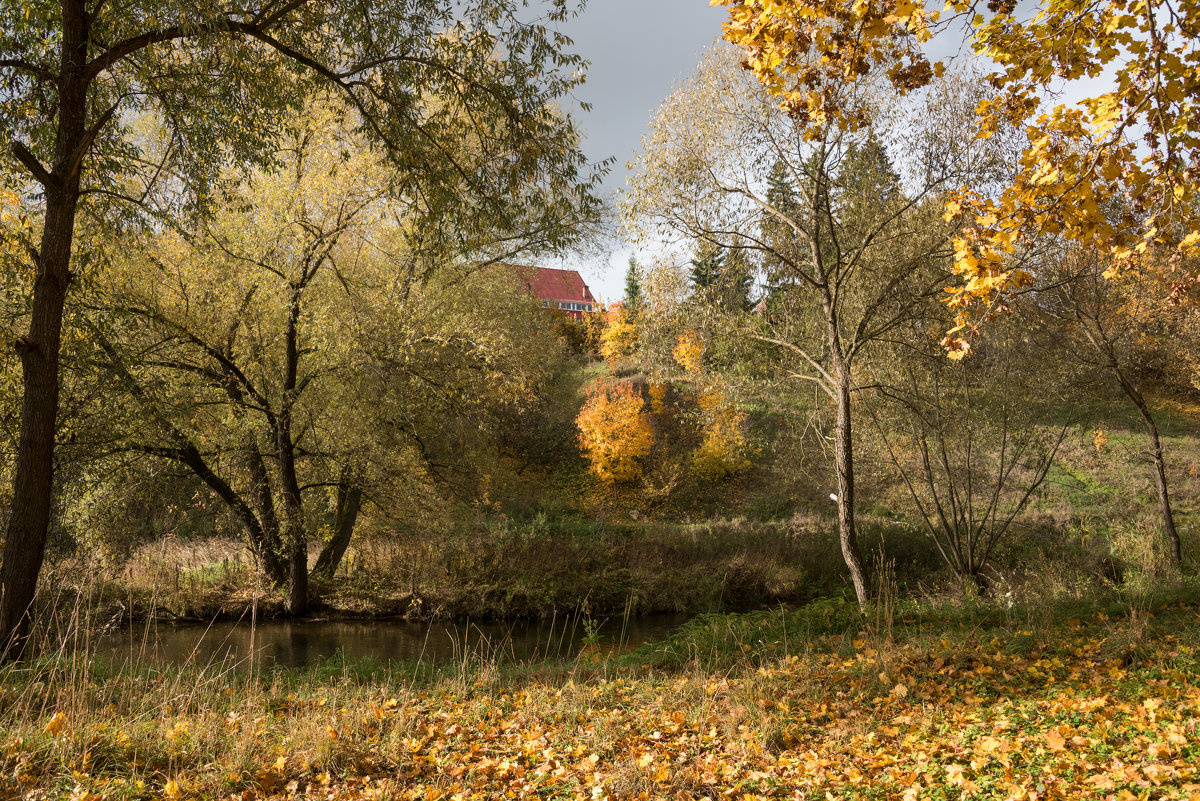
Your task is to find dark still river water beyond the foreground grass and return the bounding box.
[97,615,688,669]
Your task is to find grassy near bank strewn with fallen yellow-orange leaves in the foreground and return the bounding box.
[7,609,1200,801]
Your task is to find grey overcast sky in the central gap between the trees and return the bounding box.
[546,0,727,302]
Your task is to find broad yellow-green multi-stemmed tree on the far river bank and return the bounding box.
[95,102,578,615]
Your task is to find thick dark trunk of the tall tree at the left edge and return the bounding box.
[0,0,88,658]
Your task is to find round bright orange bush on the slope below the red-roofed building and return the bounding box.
[575,379,654,483]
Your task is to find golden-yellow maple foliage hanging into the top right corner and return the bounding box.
[720,0,1200,357]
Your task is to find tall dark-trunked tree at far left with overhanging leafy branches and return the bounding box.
[0,0,600,642]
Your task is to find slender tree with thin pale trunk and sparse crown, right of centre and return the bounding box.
[625,48,1008,603]
